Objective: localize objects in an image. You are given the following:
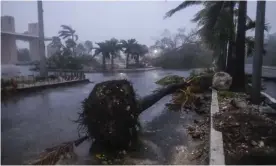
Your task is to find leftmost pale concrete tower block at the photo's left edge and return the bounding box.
[1,16,18,64]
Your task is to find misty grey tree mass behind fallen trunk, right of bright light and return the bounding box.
[149,28,212,69]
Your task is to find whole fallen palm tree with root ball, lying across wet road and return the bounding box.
[29,70,212,165]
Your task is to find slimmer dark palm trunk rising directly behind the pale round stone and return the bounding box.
[226,2,235,76]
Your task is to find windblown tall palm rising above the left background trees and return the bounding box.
[58,25,79,55]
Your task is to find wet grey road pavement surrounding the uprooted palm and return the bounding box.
[1,70,276,164]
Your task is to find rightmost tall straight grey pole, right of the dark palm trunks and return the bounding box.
[251,1,266,104]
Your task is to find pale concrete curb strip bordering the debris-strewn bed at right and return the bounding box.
[209,89,225,165]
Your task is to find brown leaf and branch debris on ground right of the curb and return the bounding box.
[214,93,276,164]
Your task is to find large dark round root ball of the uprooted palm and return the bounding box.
[77,80,139,150]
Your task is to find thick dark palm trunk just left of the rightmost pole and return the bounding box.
[232,1,247,91]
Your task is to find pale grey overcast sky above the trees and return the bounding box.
[1,0,276,48]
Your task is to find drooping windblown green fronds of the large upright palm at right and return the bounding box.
[165,1,269,73]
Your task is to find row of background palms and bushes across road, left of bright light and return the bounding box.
[47,25,148,71]
